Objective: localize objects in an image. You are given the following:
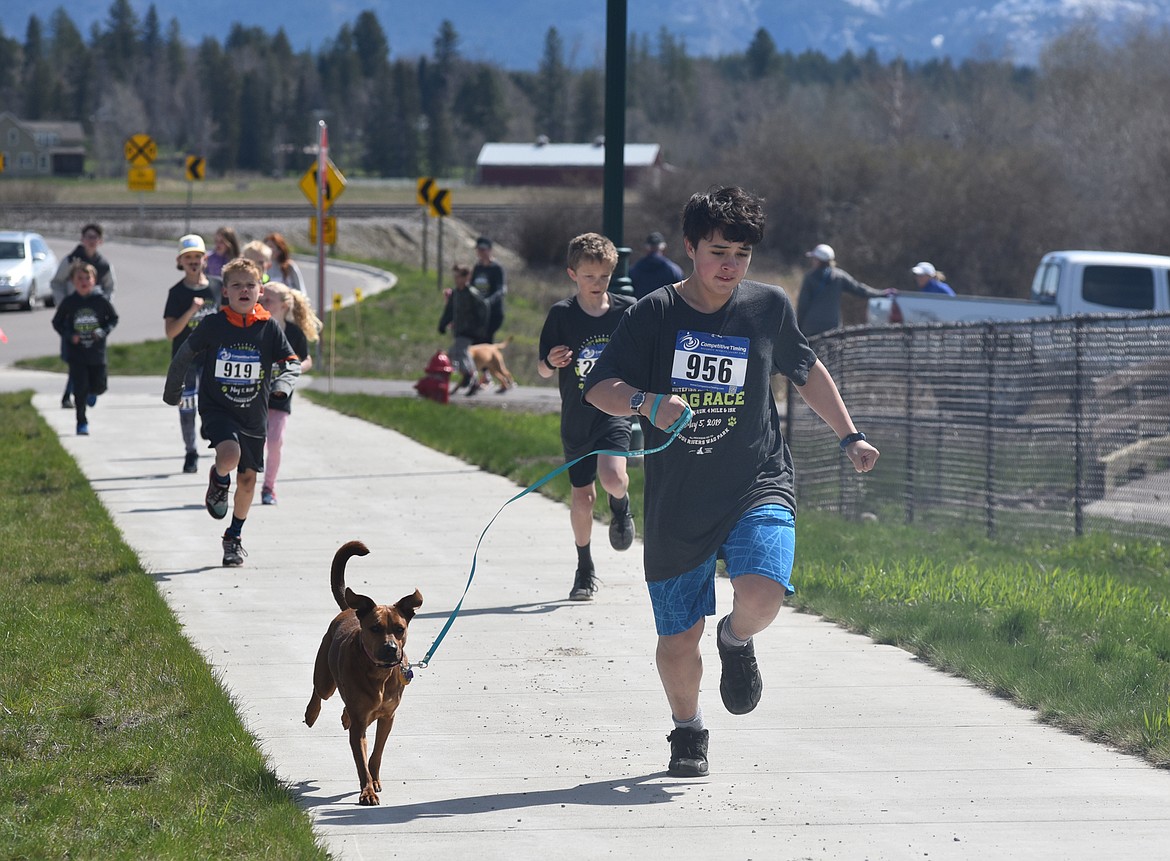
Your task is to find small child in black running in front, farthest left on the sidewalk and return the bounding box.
[53,260,118,436]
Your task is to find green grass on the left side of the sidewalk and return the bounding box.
[0,393,325,859]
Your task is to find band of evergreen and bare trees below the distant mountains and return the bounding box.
[0,0,1170,295]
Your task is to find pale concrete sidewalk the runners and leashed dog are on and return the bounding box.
[22,379,1170,861]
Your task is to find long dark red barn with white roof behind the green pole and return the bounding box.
[475,136,663,187]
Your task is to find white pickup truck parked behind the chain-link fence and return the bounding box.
[867,252,1170,325]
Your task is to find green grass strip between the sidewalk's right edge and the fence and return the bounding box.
[307,391,1170,766]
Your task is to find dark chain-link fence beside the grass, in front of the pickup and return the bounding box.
[786,314,1170,538]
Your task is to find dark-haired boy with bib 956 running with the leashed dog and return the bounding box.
[584,187,878,777]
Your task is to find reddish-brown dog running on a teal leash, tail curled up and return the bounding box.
[304,542,422,805]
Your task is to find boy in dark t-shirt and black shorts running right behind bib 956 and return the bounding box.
[536,233,634,601]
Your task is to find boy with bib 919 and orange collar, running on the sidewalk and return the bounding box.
[163,257,301,567]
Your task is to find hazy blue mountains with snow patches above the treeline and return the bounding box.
[0,0,1170,69]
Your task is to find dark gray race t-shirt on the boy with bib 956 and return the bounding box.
[585,281,817,580]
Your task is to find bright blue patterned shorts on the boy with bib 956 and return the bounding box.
[646,505,797,636]
